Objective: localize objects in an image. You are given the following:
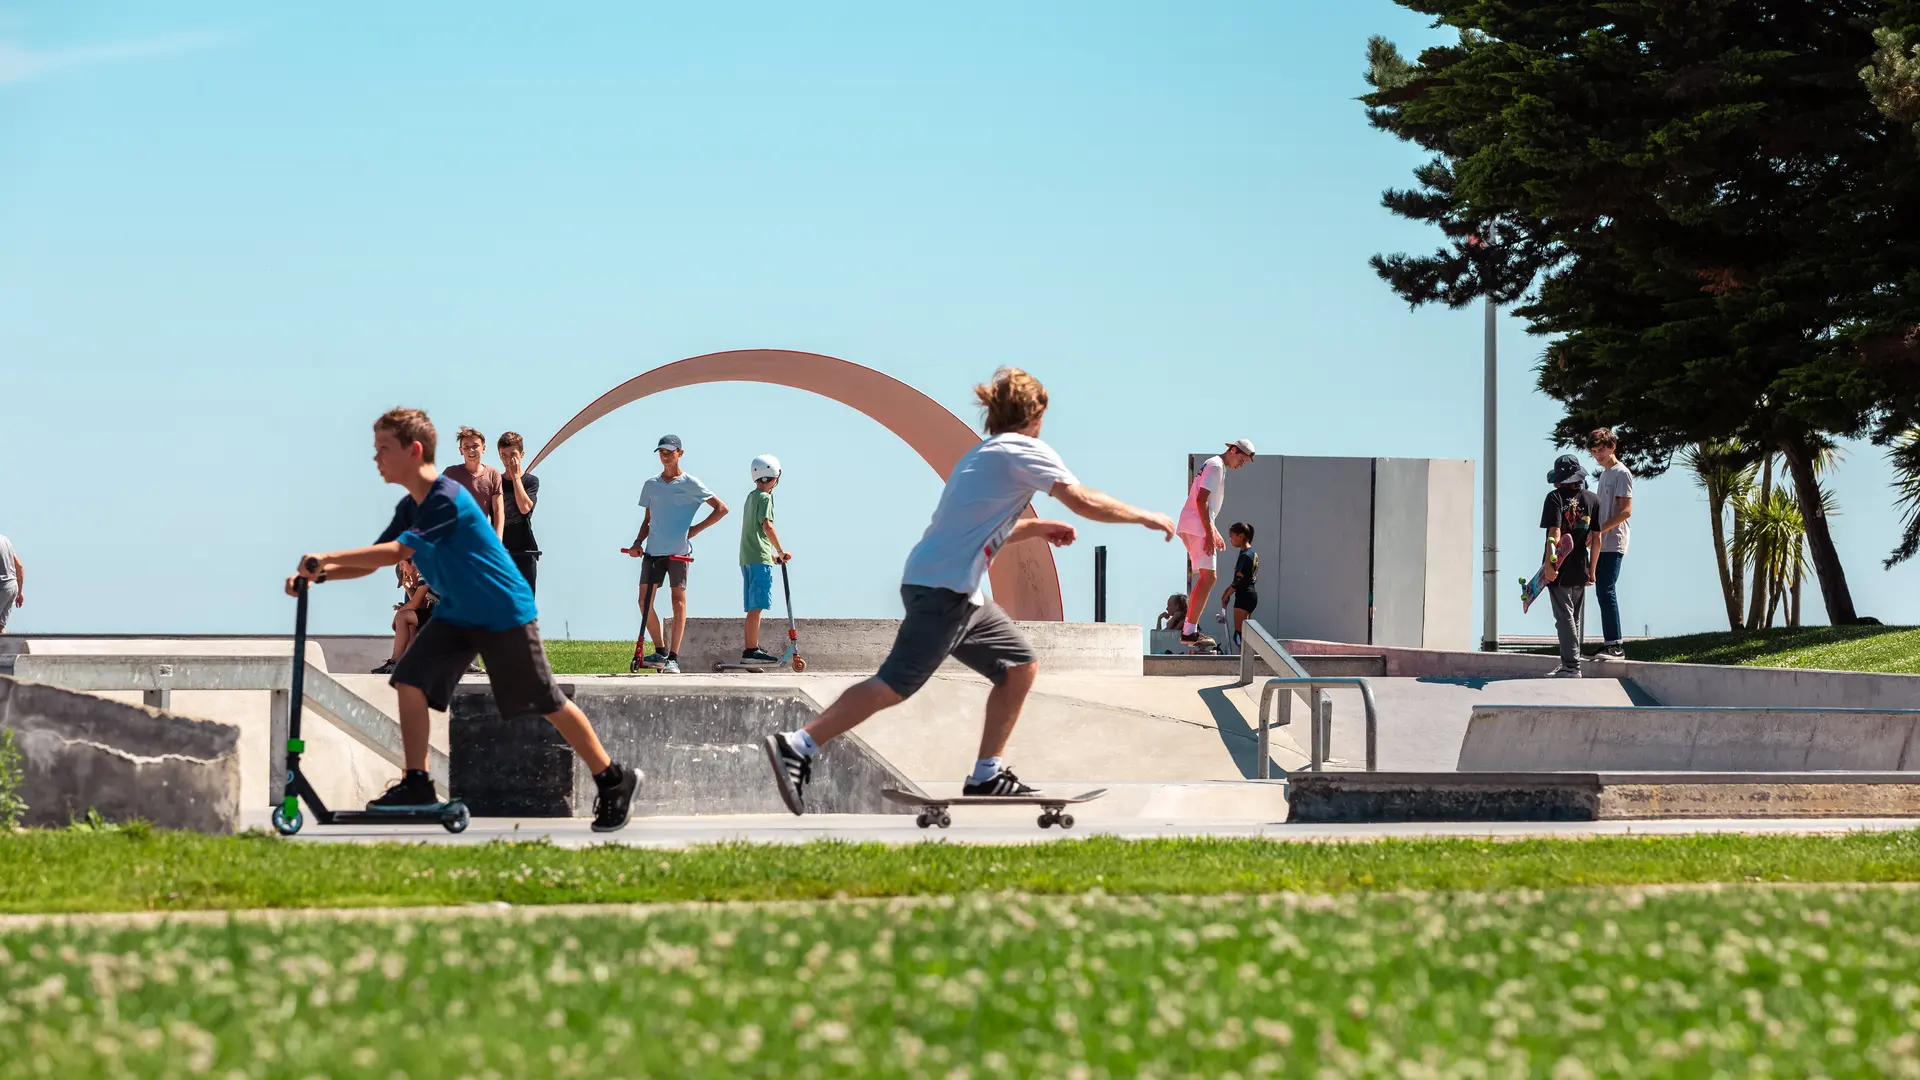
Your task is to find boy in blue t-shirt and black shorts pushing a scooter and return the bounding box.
[286,409,641,832]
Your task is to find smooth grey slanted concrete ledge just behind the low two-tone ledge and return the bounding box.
[1459,705,1920,773]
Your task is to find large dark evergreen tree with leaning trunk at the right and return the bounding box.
[1363,0,1920,621]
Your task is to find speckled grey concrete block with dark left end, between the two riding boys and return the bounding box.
[447,676,916,817]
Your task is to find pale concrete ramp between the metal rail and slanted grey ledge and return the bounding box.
[1305,678,1645,773]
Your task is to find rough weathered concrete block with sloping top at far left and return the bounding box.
[0,676,240,832]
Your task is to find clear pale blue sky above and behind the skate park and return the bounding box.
[0,0,1920,638]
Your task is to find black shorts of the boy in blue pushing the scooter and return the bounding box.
[388,619,566,717]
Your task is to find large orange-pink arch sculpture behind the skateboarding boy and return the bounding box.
[526,348,1064,623]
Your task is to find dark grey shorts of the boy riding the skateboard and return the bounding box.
[879,584,1039,698]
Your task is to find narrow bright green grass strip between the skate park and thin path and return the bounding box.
[0,830,1920,913]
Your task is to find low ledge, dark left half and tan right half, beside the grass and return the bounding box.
[1286,773,1920,824]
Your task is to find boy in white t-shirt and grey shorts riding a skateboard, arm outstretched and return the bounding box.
[766,367,1173,813]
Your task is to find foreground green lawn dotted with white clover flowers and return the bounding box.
[0,886,1920,1080]
